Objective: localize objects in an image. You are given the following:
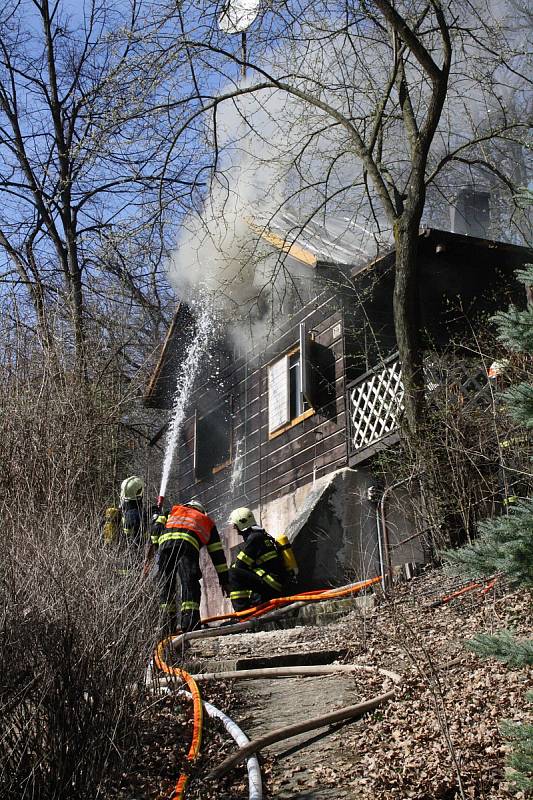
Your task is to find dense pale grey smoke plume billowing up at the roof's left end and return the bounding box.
[169,86,312,346]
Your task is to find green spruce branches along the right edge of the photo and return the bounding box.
[444,265,533,796]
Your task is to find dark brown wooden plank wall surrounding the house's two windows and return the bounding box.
[169,293,347,522]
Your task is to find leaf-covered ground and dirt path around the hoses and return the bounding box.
[102,572,533,800]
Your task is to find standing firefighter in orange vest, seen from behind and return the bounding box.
[145,500,228,631]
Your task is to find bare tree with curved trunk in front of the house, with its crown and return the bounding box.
[157,0,527,438]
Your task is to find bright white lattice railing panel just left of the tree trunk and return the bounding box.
[348,358,403,453]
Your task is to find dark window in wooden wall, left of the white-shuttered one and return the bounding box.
[194,403,231,480]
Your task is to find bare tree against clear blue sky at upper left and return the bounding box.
[0,0,196,376]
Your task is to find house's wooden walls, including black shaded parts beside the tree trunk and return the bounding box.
[160,231,527,520]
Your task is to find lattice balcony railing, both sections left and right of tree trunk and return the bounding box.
[347,356,490,455]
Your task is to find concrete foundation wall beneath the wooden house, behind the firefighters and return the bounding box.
[201,467,426,616]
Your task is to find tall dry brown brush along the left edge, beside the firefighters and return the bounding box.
[0,327,157,800]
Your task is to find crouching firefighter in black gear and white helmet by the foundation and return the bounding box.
[229,508,286,611]
